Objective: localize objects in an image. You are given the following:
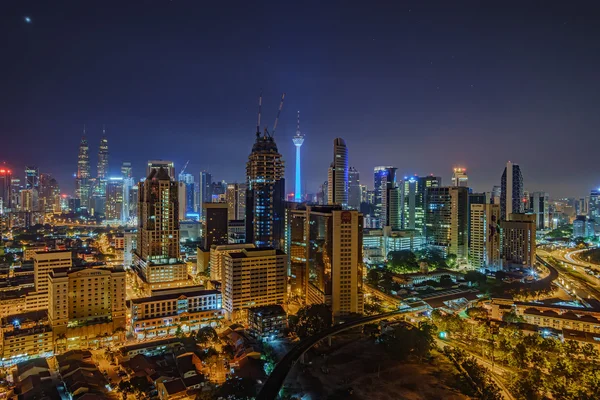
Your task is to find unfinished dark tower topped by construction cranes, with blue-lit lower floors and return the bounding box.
[246,132,285,248]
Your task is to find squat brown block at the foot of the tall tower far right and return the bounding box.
[500,213,536,268]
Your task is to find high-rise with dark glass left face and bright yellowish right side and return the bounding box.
[425,186,469,261]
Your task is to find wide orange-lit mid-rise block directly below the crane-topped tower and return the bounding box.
[221,247,287,320]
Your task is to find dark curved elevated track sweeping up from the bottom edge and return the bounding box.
[256,310,403,400]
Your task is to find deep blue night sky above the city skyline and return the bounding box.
[0,0,600,198]
